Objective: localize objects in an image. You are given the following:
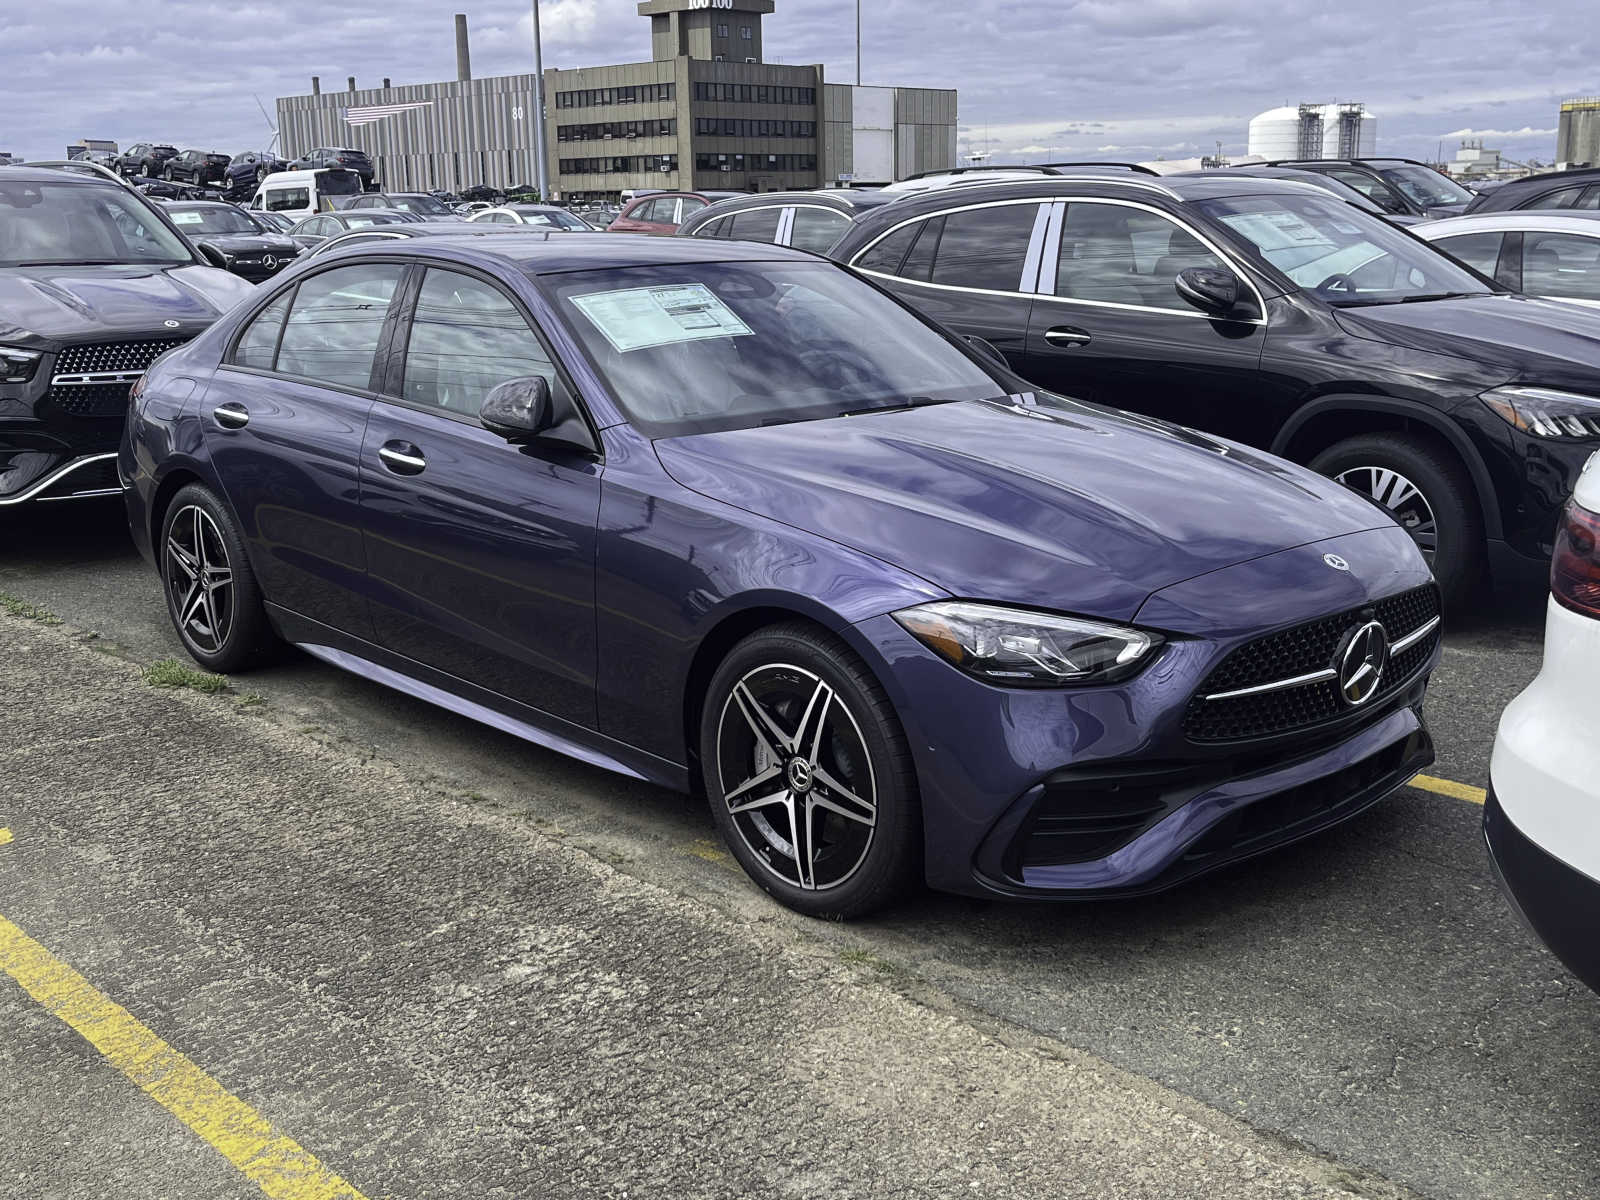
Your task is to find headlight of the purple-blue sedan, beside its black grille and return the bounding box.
[894,600,1162,688]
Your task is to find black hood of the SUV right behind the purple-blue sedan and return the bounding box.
[1336,296,1600,394]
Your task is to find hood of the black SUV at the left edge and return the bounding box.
[0,264,254,341]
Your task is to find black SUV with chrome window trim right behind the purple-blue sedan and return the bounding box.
[829,171,1600,603]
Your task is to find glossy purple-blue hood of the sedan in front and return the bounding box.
[656,395,1392,621]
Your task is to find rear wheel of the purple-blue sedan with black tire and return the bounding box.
[157,483,280,674]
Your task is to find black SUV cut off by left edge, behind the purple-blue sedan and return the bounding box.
[0,166,254,512]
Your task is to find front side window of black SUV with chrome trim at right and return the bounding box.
[1056,202,1227,312]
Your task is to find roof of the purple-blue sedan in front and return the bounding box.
[316,227,818,275]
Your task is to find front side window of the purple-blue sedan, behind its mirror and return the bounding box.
[402,267,560,418]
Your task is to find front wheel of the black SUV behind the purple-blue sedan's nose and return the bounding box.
[1310,434,1486,608]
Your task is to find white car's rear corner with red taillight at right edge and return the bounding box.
[1483,453,1600,992]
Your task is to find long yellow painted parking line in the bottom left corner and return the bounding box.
[0,917,366,1200]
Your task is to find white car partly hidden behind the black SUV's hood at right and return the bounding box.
[1410,208,1600,307]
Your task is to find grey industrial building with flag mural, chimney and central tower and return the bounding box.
[277,0,957,200]
